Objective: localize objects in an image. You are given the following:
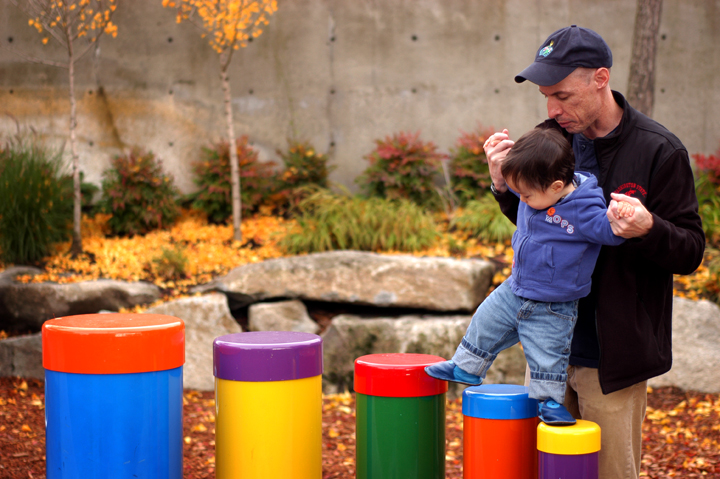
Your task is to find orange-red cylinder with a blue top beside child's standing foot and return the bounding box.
[462,384,538,479]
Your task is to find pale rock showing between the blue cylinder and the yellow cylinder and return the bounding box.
[146,293,242,391]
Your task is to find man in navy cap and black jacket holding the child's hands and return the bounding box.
[485,25,705,479]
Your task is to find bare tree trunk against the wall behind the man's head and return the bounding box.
[627,0,662,117]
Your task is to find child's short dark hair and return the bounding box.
[502,128,575,191]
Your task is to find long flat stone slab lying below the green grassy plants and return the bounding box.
[195,251,494,312]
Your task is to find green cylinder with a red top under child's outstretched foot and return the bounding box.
[355,354,447,479]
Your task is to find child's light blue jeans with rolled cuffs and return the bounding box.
[453,281,578,404]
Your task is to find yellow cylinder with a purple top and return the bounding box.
[213,331,323,479]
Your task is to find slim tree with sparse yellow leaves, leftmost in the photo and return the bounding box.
[5,0,117,256]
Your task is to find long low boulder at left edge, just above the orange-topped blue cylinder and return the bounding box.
[0,268,160,331]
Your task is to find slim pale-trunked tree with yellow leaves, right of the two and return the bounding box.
[163,0,277,241]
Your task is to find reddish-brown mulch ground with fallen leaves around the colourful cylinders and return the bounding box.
[0,378,720,479]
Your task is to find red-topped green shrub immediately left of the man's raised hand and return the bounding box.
[450,126,492,205]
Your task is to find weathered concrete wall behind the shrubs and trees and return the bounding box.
[0,0,720,191]
